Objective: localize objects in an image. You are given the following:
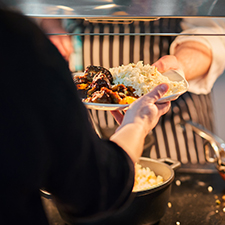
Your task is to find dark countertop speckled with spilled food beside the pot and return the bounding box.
[43,169,225,225]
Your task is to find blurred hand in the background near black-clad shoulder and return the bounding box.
[41,19,74,61]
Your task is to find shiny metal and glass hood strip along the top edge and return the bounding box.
[3,0,224,20]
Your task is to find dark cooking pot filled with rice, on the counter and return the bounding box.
[72,157,180,225]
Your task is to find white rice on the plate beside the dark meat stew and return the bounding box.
[109,61,185,97]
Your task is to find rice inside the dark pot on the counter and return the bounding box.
[133,163,163,192]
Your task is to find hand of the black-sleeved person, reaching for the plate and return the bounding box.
[110,84,170,162]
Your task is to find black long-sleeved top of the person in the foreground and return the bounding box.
[0,7,134,225]
